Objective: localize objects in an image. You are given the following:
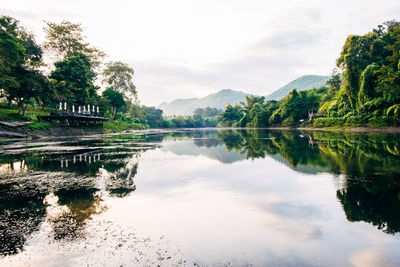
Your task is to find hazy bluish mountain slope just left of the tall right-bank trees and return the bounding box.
[265,75,329,100]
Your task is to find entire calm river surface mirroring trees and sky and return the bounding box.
[0,130,400,266]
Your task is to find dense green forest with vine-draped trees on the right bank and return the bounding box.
[219,21,400,127]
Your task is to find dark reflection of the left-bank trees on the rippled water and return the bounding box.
[0,134,162,256]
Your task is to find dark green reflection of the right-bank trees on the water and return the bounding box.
[218,130,400,234]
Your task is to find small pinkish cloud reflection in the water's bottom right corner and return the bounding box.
[350,248,394,267]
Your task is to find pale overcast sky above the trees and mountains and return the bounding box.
[0,0,400,106]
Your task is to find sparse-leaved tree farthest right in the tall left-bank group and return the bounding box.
[102,61,137,103]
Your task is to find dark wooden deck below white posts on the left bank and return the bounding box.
[37,112,108,126]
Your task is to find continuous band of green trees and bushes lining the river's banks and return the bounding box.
[0,16,400,135]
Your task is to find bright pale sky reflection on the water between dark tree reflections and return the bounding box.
[0,139,400,266]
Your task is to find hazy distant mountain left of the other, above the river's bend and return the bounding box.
[157,89,249,116]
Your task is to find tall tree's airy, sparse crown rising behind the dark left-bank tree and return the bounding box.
[44,20,105,67]
